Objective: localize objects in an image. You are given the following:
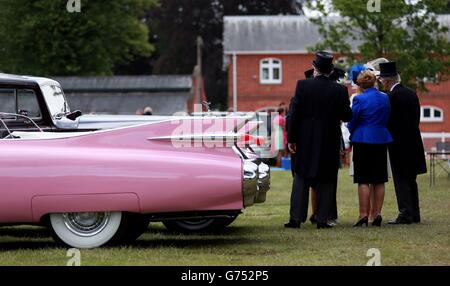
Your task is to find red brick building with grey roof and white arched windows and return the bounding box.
[224,15,450,150]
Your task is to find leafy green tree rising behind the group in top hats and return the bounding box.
[309,0,450,90]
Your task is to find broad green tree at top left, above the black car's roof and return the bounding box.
[0,0,156,76]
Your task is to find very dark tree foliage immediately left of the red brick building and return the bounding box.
[139,0,303,109]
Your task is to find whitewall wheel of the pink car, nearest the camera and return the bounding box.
[50,212,122,248]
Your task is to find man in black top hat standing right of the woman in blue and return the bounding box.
[380,62,427,224]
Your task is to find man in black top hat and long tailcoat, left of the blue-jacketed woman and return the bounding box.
[285,52,352,228]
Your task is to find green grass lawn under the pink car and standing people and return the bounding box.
[0,169,450,266]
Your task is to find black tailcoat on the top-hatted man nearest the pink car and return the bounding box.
[288,76,352,180]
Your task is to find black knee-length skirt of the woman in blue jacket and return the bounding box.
[353,143,388,184]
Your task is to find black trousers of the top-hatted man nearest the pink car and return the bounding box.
[290,174,337,223]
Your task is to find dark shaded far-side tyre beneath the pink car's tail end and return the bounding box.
[163,215,237,233]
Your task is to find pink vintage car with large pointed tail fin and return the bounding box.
[0,115,270,248]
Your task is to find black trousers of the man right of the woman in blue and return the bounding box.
[392,164,420,222]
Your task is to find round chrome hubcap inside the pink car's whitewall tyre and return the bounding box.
[63,212,110,237]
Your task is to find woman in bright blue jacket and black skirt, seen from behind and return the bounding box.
[348,71,392,226]
